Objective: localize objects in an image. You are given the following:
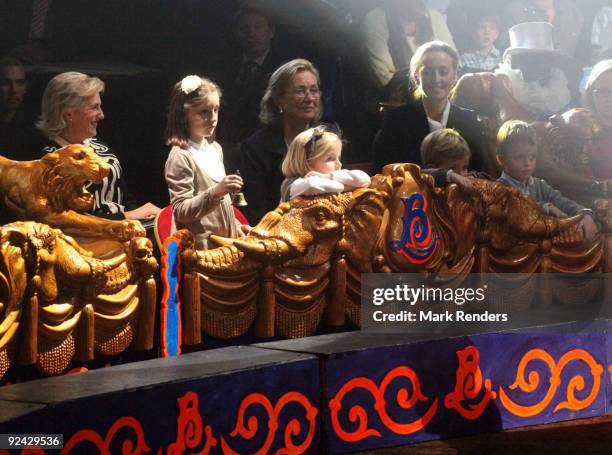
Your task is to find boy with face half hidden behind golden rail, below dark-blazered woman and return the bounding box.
[421,128,491,189]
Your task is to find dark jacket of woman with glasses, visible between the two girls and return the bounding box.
[240,127,287,226]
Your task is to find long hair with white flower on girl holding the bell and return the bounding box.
[164,77,221,150]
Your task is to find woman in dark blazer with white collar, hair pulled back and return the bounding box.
[372,41,484,172]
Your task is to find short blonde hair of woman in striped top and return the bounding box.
[36,71,104,138]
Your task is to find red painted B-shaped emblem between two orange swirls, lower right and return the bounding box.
[444,346,497,420]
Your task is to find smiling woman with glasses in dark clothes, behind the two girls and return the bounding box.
[240,59,322,225]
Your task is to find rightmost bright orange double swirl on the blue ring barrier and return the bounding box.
[499,349,603,417]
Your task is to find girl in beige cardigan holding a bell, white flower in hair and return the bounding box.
[165,76,250,248]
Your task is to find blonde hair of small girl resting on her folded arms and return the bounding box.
[281,126,342,178]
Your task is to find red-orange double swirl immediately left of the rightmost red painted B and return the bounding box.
[329,366,438,442]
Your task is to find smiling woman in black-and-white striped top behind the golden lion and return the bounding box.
[36,72,160,219]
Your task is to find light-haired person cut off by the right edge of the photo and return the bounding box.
[582,60,612,179]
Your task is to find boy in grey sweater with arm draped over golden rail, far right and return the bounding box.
[497,120,598,239]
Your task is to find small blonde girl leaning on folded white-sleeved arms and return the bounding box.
[281,125,370,202]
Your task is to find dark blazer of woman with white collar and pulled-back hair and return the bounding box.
[372,100,484,173]
